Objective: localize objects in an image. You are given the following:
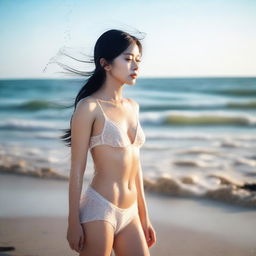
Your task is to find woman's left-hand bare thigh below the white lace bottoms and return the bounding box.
[79,220,114,256]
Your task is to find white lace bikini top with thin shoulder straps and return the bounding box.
[89,99,146,150]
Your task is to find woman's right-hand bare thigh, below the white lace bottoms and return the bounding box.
[113,215,150,256]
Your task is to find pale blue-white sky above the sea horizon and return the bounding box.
[0,0,256,78]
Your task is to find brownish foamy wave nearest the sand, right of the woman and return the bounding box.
[144,175,256,208]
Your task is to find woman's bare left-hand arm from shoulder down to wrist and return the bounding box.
[68,99,96,225]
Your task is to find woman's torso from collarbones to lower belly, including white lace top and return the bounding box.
[86,96,145,208]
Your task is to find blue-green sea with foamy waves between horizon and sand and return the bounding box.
[0,77,256,208]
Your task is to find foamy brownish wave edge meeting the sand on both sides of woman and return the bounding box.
[0,158,256,208]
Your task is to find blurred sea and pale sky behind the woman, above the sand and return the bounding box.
[0,0,256,206]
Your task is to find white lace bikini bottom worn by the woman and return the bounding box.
[79,185,138,235]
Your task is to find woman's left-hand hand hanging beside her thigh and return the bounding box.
[67,222,85,253]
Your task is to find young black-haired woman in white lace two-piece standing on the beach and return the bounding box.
[62,29,156,256]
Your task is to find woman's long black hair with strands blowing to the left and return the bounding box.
[60,29,145,147]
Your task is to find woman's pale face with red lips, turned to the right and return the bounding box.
[109,43,141,85]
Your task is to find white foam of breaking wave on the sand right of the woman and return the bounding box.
[144,173,256,208]
